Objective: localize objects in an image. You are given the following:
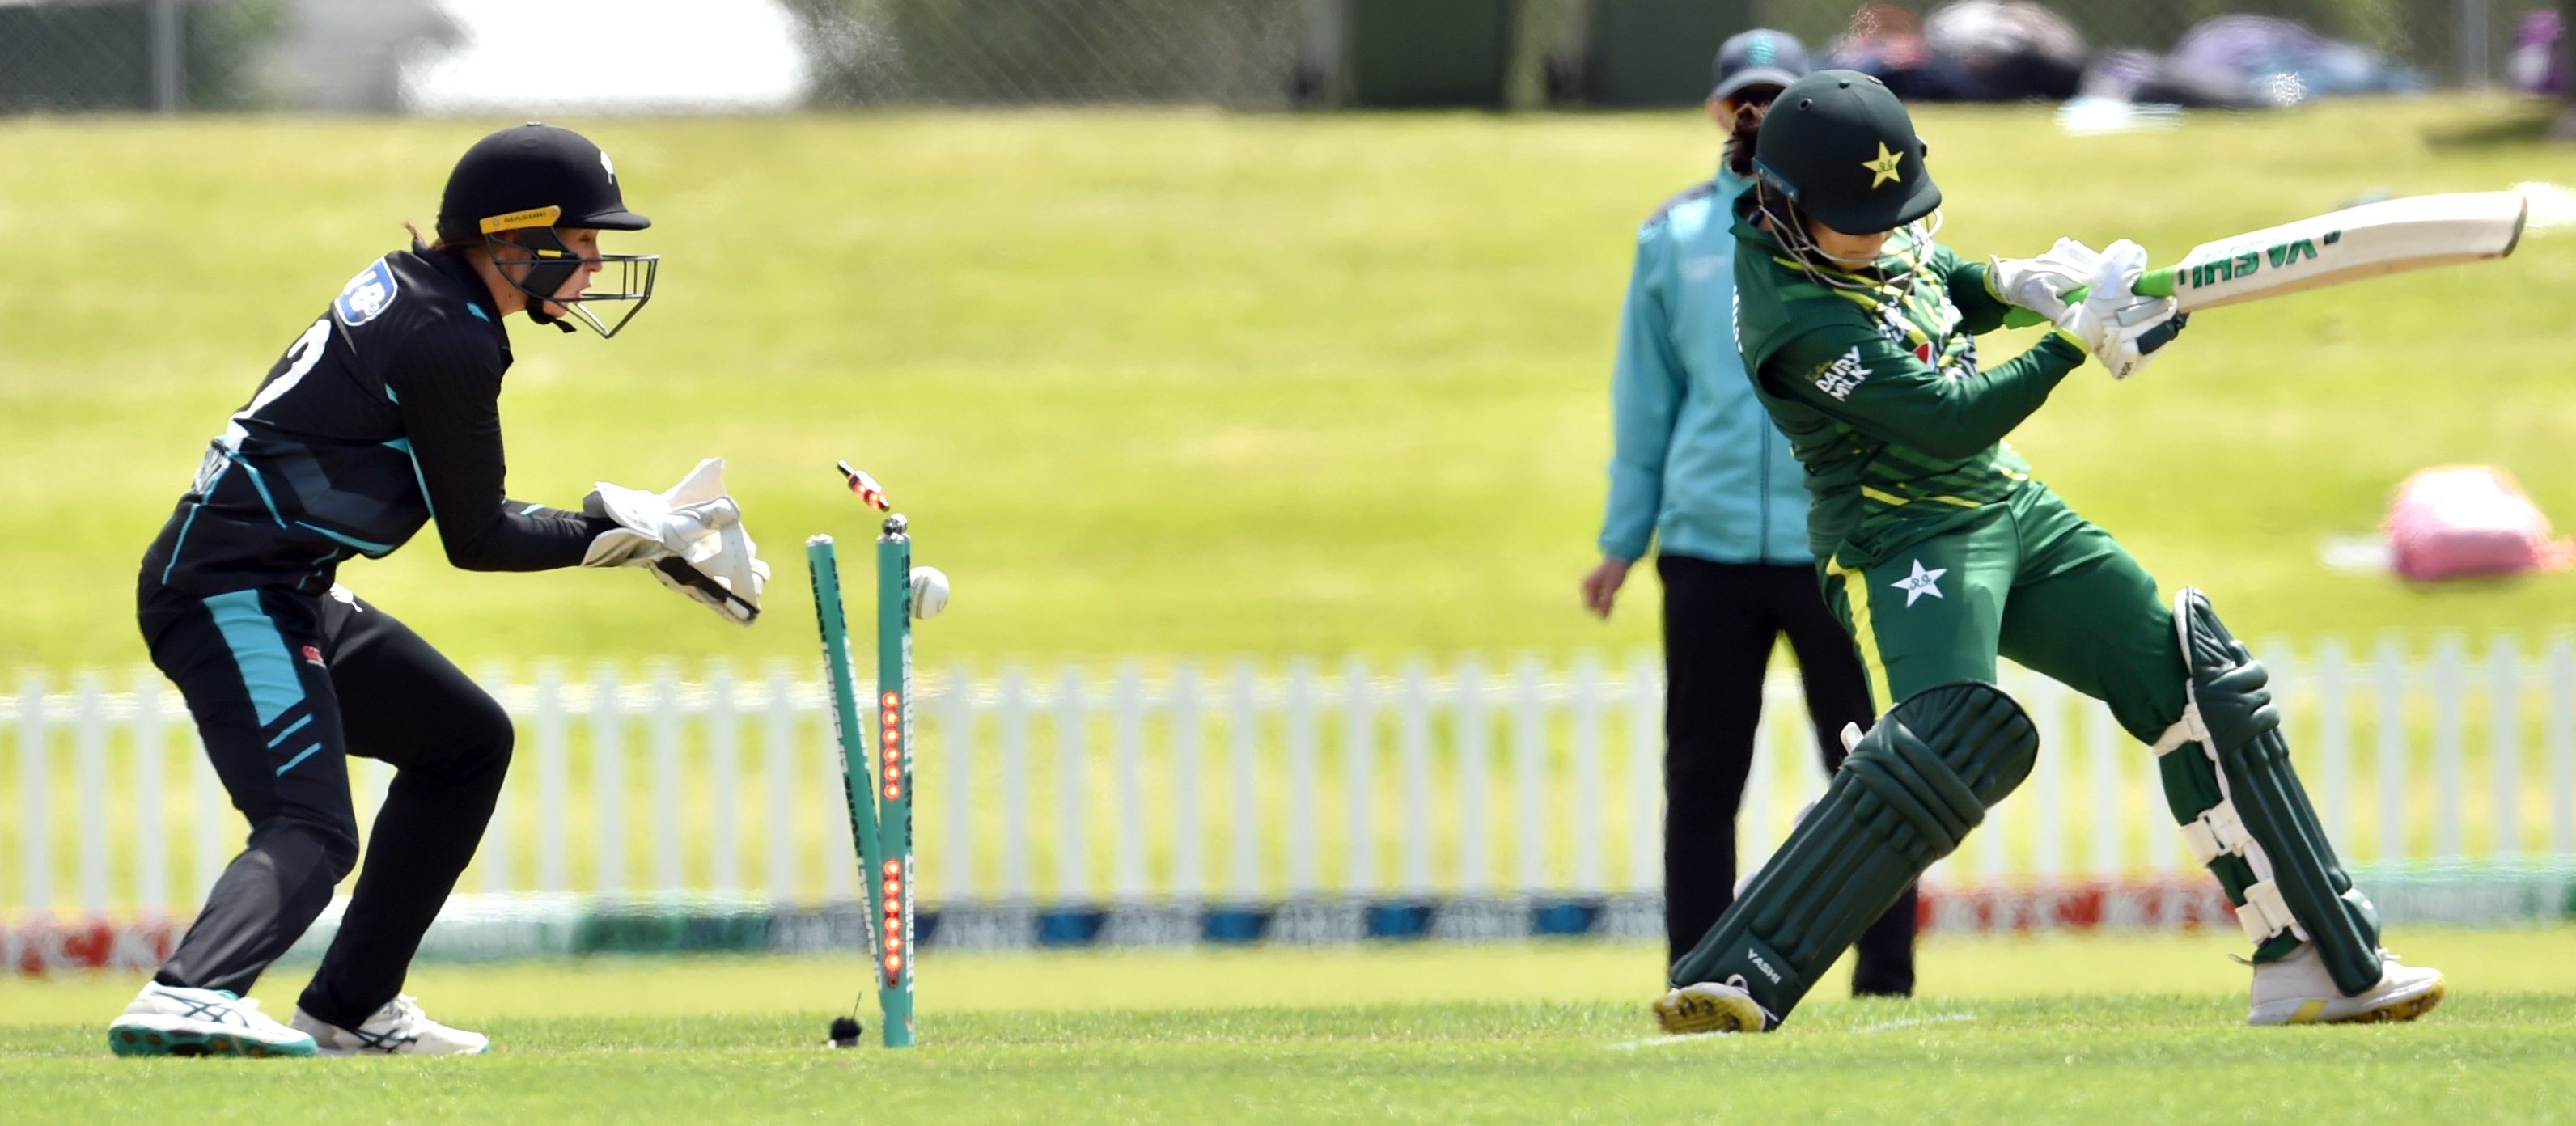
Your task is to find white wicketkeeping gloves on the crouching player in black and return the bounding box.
[583,459,770,626]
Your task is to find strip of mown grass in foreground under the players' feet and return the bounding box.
[0,928,2576,1124]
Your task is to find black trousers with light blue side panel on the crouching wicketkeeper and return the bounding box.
[142,582,510,1028]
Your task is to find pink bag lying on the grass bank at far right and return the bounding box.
[2385,467,2576,582]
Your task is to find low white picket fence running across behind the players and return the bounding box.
[0,637,2576,920]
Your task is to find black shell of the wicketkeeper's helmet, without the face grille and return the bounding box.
[438,121,652,242]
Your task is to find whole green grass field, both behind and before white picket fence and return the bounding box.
[15,98,2576,1124]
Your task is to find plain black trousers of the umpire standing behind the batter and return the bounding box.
[1654,554,1914,997]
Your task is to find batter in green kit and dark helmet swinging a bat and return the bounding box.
[1654,70,2442,1033]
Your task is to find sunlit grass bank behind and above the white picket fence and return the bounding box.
[0,98,2576,670]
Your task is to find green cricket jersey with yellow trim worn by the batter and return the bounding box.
[1736,196,2084,565]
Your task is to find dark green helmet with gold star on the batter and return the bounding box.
[1754,70,1940,235]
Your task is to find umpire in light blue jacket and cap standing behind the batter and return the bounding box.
[1584,31,1914,997]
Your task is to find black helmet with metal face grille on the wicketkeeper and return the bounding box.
[438,121,662,337]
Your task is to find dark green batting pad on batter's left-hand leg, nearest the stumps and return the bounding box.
[1671,680,2040,1026]
